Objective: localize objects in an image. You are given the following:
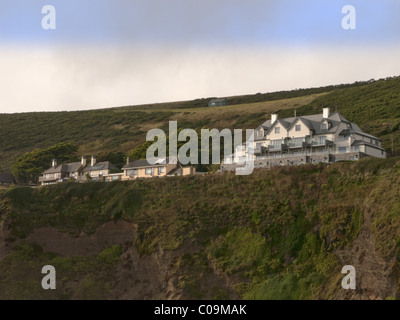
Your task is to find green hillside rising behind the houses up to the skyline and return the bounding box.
[0,77,400,172]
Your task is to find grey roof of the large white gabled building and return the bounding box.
[261,112,379,140]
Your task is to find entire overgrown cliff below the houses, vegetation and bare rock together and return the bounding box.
[0,157,400,299]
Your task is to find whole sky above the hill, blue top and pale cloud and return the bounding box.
[0,0,400,113]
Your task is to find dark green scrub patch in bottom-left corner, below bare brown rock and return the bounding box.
[0,242,121,300]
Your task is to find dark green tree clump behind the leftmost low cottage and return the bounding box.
[11,142,78,183]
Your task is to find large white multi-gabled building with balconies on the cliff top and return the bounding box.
[221,108,386,171]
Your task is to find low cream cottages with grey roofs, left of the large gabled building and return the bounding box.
[39,156,196,185]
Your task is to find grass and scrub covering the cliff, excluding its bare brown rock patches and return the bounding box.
[0,158,400,299]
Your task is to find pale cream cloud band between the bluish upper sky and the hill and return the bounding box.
[0,42,400,113]
